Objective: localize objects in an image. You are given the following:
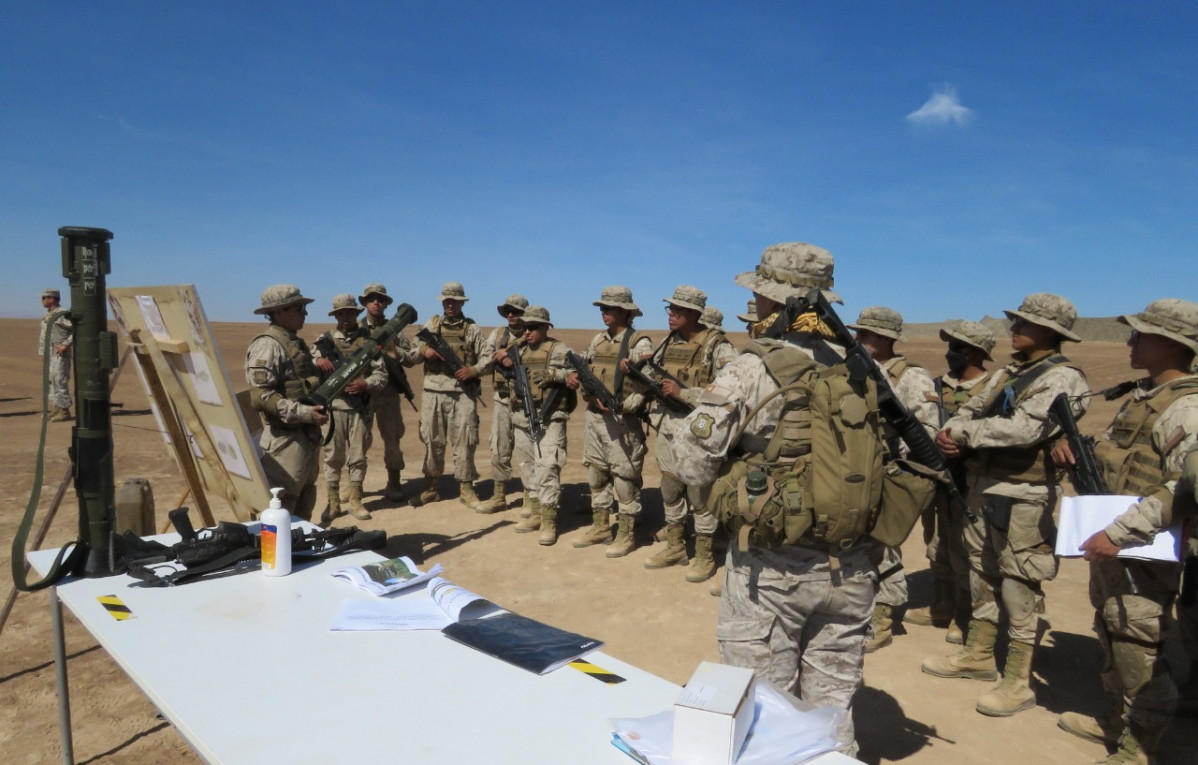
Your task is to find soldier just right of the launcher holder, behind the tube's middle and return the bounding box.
[313,293,387,526]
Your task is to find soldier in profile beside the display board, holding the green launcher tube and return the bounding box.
[246,284,328,521]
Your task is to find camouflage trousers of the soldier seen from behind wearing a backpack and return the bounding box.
[715,545,876,753]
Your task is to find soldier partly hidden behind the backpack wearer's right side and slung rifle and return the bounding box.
[848,305,940,654]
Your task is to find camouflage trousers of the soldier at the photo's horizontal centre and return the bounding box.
[582,409,646,516]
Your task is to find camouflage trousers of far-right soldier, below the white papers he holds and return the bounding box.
[1090,559,1181,742]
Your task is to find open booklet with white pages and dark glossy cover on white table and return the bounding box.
[331,577,603,675]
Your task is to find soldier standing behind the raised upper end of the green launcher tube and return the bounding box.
[358,283,418,504]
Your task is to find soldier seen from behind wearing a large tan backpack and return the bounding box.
[671,242,877,754]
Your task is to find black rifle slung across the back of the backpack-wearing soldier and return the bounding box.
[762,287,978,523]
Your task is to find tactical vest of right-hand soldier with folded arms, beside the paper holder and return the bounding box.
[966,353,1077,486]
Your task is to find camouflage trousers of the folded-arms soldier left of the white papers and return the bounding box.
[964,491,1058,643]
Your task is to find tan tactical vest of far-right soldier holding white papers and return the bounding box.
[1094,377,1198,497]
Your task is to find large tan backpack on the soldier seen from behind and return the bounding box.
[691,339,896,550]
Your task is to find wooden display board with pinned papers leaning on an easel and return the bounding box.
[108,285,270,526]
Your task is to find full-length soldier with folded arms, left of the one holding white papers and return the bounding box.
[922,293,1090,717]
